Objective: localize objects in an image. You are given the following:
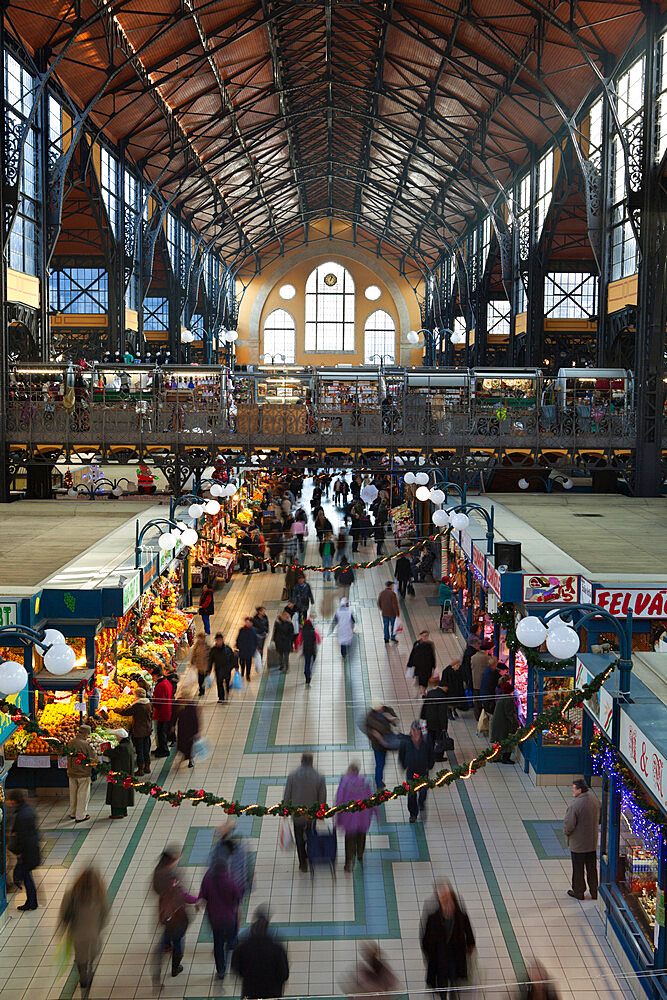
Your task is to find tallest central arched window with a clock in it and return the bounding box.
[305,261,354,351]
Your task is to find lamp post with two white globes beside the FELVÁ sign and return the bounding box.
[516,604,632,701]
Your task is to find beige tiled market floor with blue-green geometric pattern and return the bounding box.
[0,480,629,1000]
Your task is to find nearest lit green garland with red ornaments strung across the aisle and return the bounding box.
[0,665,614,819]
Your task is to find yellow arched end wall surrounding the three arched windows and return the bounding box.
[236,239,421,365]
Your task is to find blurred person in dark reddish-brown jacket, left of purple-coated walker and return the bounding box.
[153,847,197,989]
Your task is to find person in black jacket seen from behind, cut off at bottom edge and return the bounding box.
[232,909,289,1000]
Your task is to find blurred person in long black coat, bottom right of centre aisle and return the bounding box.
[421,879,475,1000]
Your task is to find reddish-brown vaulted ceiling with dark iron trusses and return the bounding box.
[5,0,644,268]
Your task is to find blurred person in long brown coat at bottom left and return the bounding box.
[58,866,109,997]
